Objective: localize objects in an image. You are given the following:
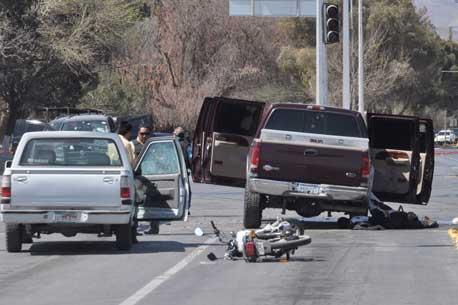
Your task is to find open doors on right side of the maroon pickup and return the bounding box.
[367,113,434,204]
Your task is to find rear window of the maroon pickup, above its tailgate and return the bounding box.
[265,109,363,138]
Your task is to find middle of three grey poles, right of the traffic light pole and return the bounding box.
[342,0,351,109]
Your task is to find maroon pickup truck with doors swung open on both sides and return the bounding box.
[192,97,434,228]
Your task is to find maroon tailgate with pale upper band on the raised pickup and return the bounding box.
[258,129,368,186]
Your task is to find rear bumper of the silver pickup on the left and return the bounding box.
[0,209,131,225]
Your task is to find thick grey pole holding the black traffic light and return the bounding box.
[316,0,328,106]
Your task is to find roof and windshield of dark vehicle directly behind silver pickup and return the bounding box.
[49,114,116,132]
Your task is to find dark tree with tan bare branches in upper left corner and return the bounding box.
[0,0,143,135]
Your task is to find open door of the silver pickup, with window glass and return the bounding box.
[135,137,191,221]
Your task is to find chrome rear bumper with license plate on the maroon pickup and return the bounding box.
[247,178,368,201]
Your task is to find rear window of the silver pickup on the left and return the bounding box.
[20,138,122,166]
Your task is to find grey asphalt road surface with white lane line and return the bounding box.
[0,150,458,305]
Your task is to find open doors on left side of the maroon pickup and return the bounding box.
[192,97,265,186]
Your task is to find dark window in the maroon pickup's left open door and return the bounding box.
[214,102,262,136]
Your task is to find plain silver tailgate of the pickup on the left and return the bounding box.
[11,168,123,208]
